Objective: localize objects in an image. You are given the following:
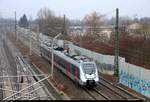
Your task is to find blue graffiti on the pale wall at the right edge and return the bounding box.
[119,70,150,97]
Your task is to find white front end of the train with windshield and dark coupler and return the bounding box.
[81,62,99,86]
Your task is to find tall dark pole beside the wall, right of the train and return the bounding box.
[114,8,119,79]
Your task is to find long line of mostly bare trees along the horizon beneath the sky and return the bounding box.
[18,8,150,37]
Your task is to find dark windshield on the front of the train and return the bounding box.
[83,63,96,75]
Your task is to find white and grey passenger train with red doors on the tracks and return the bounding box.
[40,44,99,86]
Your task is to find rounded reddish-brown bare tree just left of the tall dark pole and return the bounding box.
[83,12,107,47]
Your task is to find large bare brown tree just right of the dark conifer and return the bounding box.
[37,8,68,37]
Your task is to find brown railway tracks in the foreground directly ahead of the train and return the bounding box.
[83,79,144,101]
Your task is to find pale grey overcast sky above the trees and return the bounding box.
[0,0,150,19]
